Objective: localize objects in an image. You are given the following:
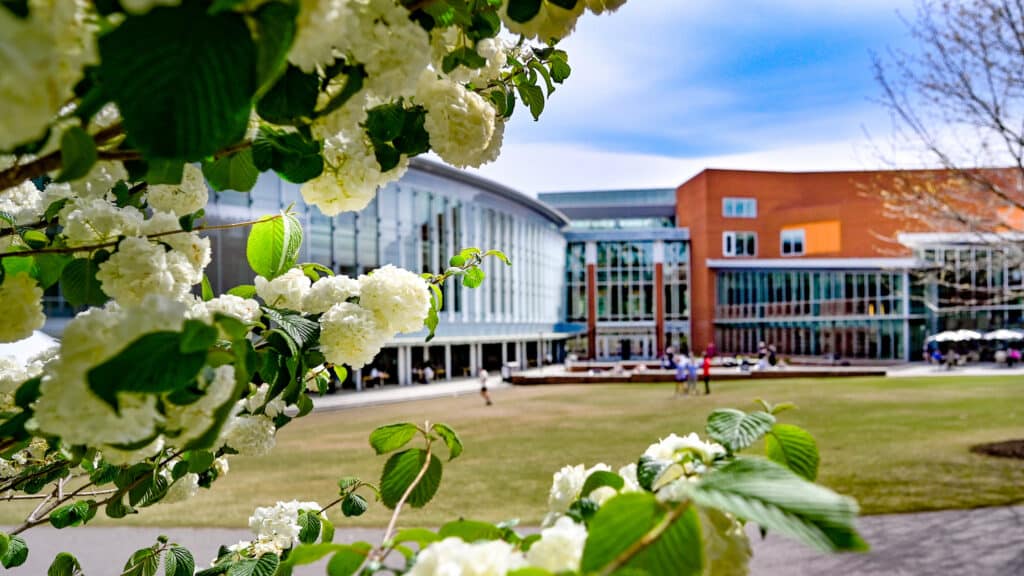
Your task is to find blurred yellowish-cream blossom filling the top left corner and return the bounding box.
[0,0,95,150]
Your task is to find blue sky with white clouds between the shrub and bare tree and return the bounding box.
[468,0,913,193]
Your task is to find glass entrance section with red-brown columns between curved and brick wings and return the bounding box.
[540,189,689,360]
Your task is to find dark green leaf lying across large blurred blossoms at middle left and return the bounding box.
[87,332,206,410]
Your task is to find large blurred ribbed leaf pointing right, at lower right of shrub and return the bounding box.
[691,458,867,551]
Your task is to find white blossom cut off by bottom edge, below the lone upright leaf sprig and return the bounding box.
[406,537,526,576]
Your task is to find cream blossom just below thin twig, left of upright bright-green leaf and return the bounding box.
[96,237,195,305]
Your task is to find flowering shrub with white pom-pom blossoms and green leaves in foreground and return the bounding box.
[0,0,859,576]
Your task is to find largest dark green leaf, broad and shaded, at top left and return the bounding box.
[98,0,257,161]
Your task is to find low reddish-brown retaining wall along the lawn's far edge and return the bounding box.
[505,368,886,386]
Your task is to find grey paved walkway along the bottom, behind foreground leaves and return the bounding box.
[13,506,1024,576]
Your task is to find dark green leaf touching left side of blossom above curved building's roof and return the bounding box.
[252,126,324,183]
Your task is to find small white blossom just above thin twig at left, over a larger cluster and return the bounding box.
[59,198,143,246]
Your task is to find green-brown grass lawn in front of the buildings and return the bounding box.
[8,377,1024,527]
